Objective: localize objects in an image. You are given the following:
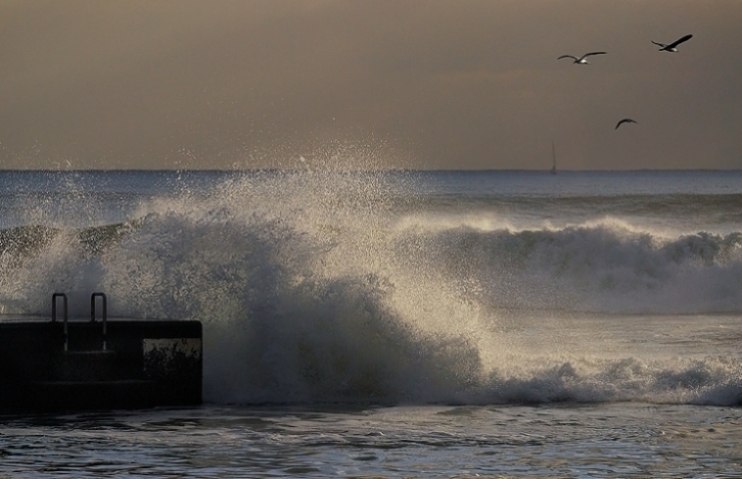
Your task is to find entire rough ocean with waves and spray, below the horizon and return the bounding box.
[0,168,742,478]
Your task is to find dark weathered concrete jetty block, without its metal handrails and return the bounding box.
[0,319,203,411]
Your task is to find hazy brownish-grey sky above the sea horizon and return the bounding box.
[0,0,742,170]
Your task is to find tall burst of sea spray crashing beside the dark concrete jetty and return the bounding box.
[55,167,479,402]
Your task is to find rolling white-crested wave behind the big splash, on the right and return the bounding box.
[397,222,742,314]
